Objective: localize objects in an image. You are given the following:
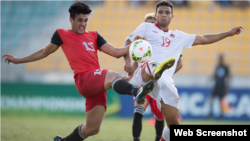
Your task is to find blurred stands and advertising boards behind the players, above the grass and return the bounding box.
[0,0,250,124]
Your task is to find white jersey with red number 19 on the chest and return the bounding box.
[126,23,196,76]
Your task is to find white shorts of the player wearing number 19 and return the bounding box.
[134,67,179,110]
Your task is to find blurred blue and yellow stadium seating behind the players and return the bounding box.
[0,0,250,83]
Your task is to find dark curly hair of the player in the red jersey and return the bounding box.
[69,2,92,20]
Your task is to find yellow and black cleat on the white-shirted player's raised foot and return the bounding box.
[153,58,175,79]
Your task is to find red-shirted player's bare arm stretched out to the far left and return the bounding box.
[2,43,59,64]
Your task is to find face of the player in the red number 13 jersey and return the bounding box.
[70,14,89,34]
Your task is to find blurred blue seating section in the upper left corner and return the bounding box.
[0,0,68,48]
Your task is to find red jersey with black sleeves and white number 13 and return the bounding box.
[51,29,106,75]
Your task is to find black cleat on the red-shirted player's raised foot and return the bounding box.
[135,80,155,104]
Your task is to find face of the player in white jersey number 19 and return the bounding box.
[155,6,174,27]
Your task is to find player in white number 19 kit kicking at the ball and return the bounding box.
[125,0,243,141]
